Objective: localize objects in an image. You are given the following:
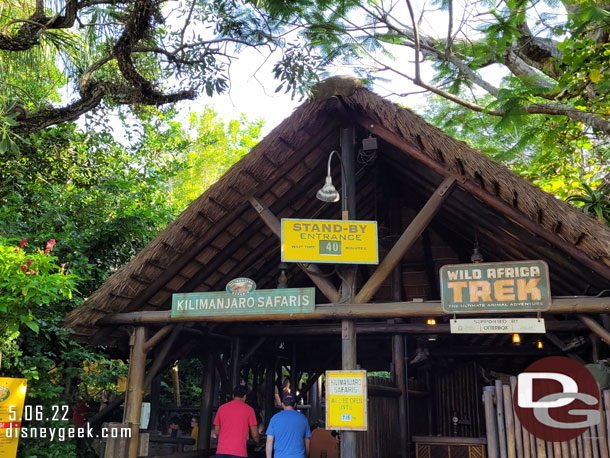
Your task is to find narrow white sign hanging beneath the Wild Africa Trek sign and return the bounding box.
[450,318,546,334]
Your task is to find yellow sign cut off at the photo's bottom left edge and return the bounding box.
[0,377,27,458]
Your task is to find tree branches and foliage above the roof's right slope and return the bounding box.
[255,0,610,220]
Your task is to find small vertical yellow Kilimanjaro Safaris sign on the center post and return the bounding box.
[326,370,368,431]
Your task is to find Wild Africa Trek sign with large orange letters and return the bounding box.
[440,261,551,313]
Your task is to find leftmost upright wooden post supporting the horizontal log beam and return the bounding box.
[123,326,146,458]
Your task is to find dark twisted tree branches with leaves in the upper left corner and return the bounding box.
[0,0,307,137]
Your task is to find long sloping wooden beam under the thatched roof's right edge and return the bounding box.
[358,117,610,280]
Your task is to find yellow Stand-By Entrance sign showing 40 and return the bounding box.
[282,218,379,264]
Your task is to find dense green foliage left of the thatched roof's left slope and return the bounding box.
[0,107,261,457]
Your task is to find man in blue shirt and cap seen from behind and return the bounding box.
[265,393,311,458]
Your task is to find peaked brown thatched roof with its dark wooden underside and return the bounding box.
[65,77,610,338]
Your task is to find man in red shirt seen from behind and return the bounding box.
[214,385,260,458]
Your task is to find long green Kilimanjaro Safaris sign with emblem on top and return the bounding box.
[172,279,316,317]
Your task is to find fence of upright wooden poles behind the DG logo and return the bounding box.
[483,376,610,458]
